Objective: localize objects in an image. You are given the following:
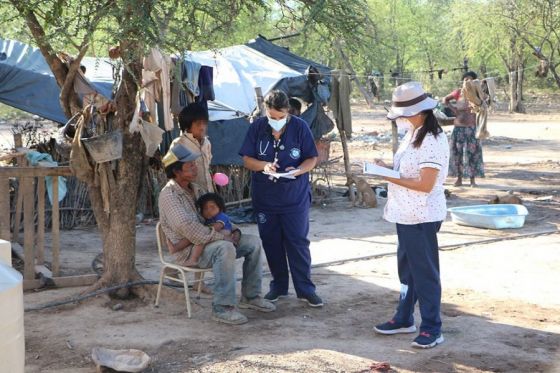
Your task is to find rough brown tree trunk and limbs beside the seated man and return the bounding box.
[11,0,152,297]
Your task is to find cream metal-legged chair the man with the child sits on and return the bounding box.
[155,223,212,319]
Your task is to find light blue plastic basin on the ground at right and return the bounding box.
[447,204,529,229]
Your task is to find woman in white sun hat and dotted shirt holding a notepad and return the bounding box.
[374,82,449,348]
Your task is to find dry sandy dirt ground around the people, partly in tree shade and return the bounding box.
[9,102,560,373]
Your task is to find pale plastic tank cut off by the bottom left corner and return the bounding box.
[0,261,25,373]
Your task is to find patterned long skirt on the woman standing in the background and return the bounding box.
[449,127,484,178]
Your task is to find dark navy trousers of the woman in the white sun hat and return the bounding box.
[393,221,442,335]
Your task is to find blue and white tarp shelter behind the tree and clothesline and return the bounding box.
[0,37,332,165]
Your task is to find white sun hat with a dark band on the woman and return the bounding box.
[387,82,438,120]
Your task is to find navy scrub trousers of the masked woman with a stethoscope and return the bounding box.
[257,208,315,298]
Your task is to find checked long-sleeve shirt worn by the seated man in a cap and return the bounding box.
[159,179,224,255]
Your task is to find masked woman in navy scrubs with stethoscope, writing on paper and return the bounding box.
[239,91,323,307]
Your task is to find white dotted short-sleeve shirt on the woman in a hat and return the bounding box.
[383,129,449,225]
